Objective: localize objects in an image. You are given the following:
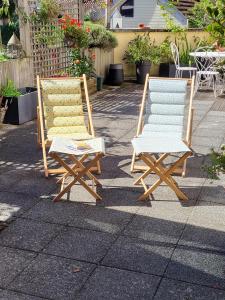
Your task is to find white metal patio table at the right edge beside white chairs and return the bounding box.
[189,51,225,97]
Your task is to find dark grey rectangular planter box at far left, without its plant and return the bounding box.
[3,87,37,125]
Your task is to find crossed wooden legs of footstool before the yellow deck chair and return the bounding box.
[49,152,104,202]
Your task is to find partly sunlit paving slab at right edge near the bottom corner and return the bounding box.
[165,246,225,289]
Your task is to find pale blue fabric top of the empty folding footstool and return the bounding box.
[131,136,191,155]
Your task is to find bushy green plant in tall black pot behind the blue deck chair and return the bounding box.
[124,34,160,84]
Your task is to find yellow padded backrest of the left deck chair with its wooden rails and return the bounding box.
[37,77,94,140]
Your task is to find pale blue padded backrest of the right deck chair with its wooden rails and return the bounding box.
[137,76,194,141]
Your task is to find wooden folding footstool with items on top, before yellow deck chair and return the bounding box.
[49,137,105,202]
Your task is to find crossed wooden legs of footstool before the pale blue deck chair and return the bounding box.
[134,151,192,200]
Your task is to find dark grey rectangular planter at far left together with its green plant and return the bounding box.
[2,80,37,125]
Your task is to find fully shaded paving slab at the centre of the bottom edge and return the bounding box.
[78,267,160,300]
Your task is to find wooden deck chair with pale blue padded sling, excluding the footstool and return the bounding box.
[131,75,195,176]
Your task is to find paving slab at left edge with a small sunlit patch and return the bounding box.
[0,192,39,221]
